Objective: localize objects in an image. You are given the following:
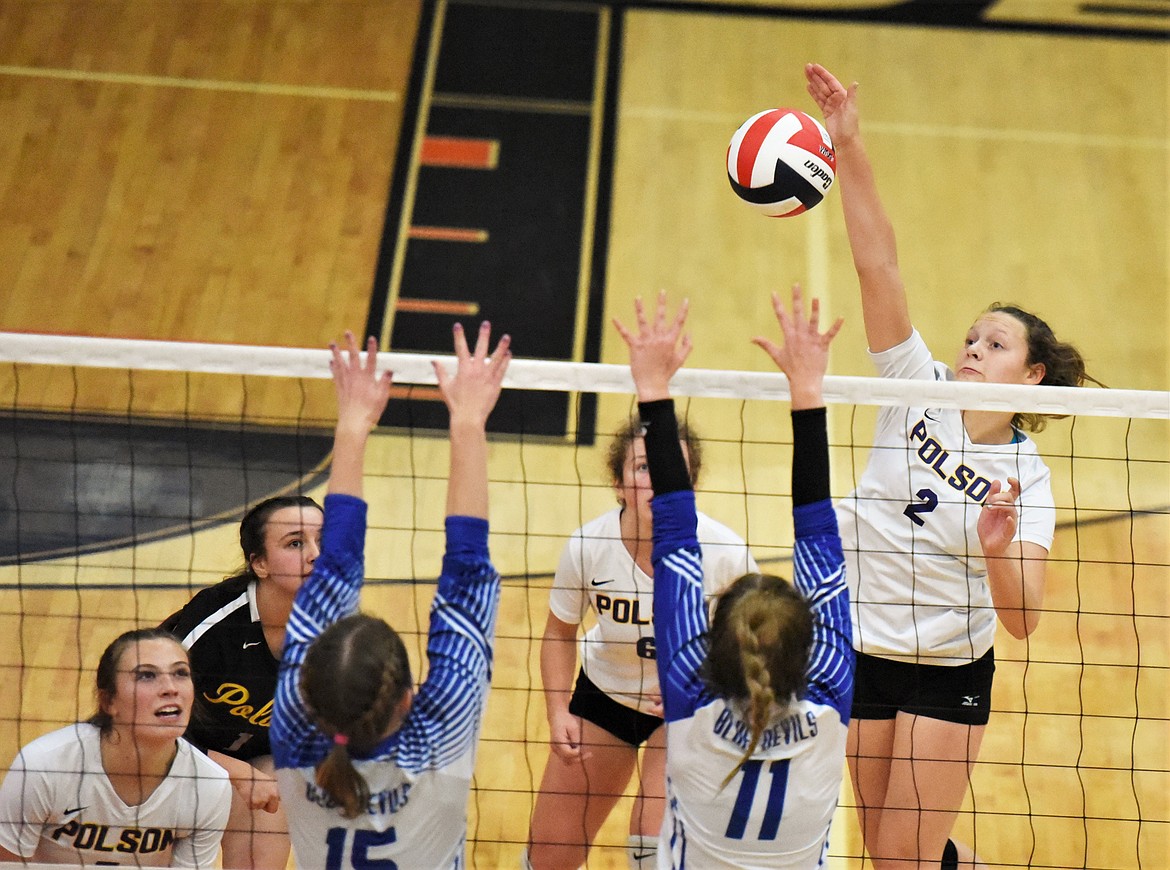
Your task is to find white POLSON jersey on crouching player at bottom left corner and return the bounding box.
[0,723,232,868]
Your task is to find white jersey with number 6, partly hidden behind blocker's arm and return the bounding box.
[549,508,759,713]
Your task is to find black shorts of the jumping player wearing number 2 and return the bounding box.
[853,649,996,725]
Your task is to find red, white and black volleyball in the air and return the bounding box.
[728,109,837,218]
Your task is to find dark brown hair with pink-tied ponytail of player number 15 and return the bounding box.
[301,614,411,819]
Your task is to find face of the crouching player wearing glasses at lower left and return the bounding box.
[105,637,195,740]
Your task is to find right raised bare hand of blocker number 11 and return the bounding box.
[751,284,844,410]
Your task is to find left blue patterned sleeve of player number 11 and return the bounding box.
[651,490,707,721]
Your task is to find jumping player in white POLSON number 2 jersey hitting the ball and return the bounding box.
[805,63,1087,870]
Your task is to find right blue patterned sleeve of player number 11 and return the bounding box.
[792,498,854,724]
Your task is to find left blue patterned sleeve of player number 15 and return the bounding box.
[270,495,366,767]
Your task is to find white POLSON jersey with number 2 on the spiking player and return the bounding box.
[838,330,1055,665]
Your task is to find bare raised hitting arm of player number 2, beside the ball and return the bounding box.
[805,63,910,353]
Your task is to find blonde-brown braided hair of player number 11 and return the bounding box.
[702,573,812,786]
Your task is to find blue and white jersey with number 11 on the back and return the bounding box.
[653,490,853,870]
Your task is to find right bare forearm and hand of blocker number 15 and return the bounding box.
[434,320,511,519]
